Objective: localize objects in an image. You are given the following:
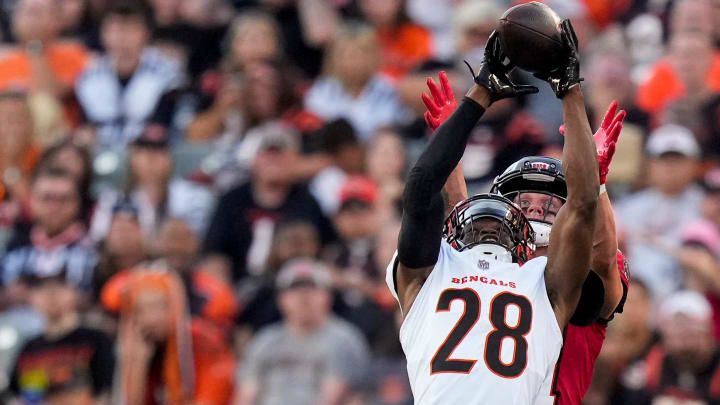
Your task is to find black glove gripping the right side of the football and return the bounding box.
[534,19,583,98]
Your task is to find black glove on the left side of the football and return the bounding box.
[465,31,538,104]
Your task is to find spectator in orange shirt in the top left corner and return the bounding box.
[0,0,88,99]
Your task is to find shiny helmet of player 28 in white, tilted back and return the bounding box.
[443,194,535,263]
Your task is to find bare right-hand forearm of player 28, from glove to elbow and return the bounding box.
[563,86,600,216]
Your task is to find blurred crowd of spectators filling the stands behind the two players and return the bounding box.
[0,0,720,405]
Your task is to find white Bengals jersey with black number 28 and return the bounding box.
[386,241,563,405]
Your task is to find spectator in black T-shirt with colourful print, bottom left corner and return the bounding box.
[10,269,115,405]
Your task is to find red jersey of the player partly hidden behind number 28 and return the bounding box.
[549,250,630,405]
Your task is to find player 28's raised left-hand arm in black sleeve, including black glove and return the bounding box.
[394,33,537,313]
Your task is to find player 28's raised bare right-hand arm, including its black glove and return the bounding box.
[542,20,600,328]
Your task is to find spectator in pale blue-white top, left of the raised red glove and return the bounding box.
[305,25,410,140]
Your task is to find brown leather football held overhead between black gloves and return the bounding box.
[498,1,564,73]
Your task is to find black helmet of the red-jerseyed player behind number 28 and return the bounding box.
[490,156,567,246]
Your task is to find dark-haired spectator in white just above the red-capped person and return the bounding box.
[310,118,363,216]
